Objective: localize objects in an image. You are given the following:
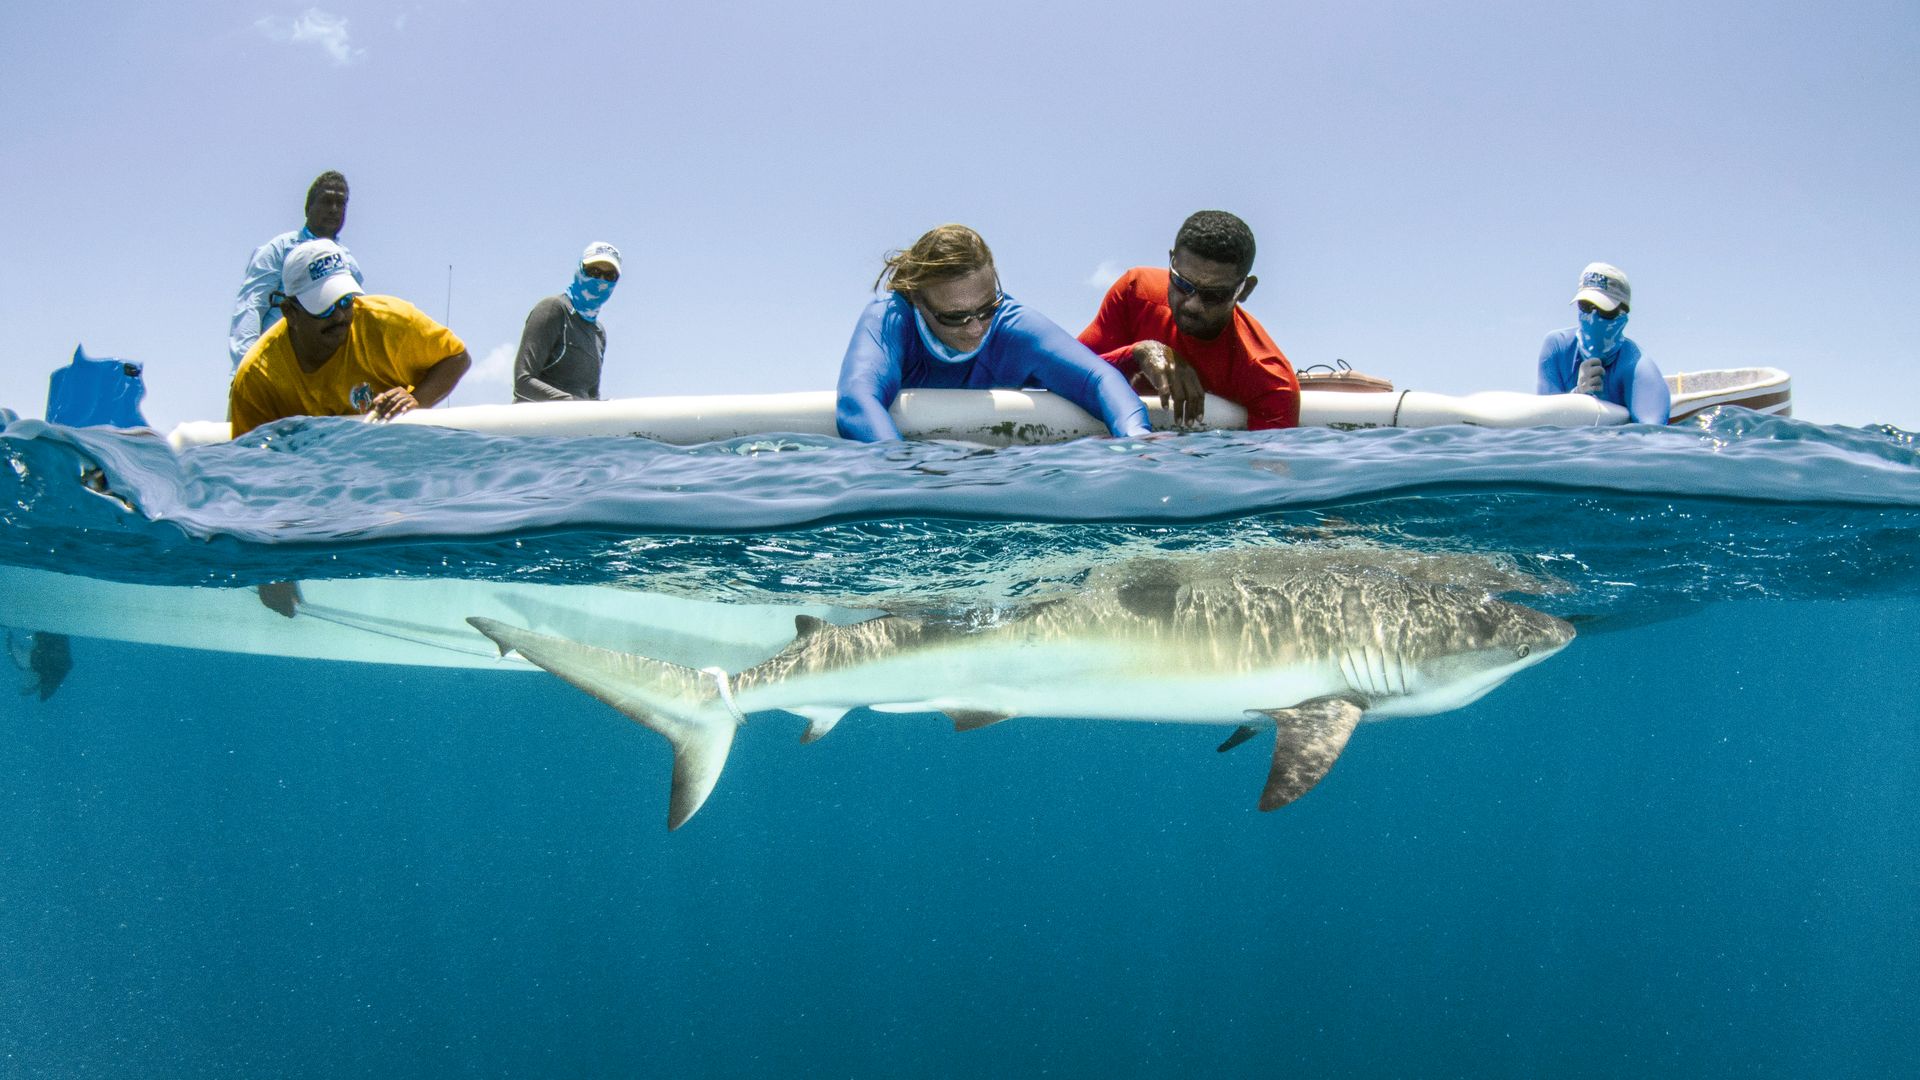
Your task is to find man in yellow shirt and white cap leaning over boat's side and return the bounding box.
[227,240,472,438]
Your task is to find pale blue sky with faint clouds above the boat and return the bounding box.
[0,0,1920,430]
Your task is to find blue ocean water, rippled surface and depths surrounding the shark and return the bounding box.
[0,409,1920,1078]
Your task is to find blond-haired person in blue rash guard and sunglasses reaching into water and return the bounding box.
[839,225,1150,442]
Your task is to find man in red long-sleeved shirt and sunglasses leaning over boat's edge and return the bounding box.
[1079,209,1300,430]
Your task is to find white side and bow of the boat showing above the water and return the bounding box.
[167,367,1791,450]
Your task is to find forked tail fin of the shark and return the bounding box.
[467,617,741,828]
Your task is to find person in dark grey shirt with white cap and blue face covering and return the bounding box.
[513,242,620,402]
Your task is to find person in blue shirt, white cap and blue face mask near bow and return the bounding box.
[1540,263,1672,425]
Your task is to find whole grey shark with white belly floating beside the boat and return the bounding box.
[468,559,1574,830]
